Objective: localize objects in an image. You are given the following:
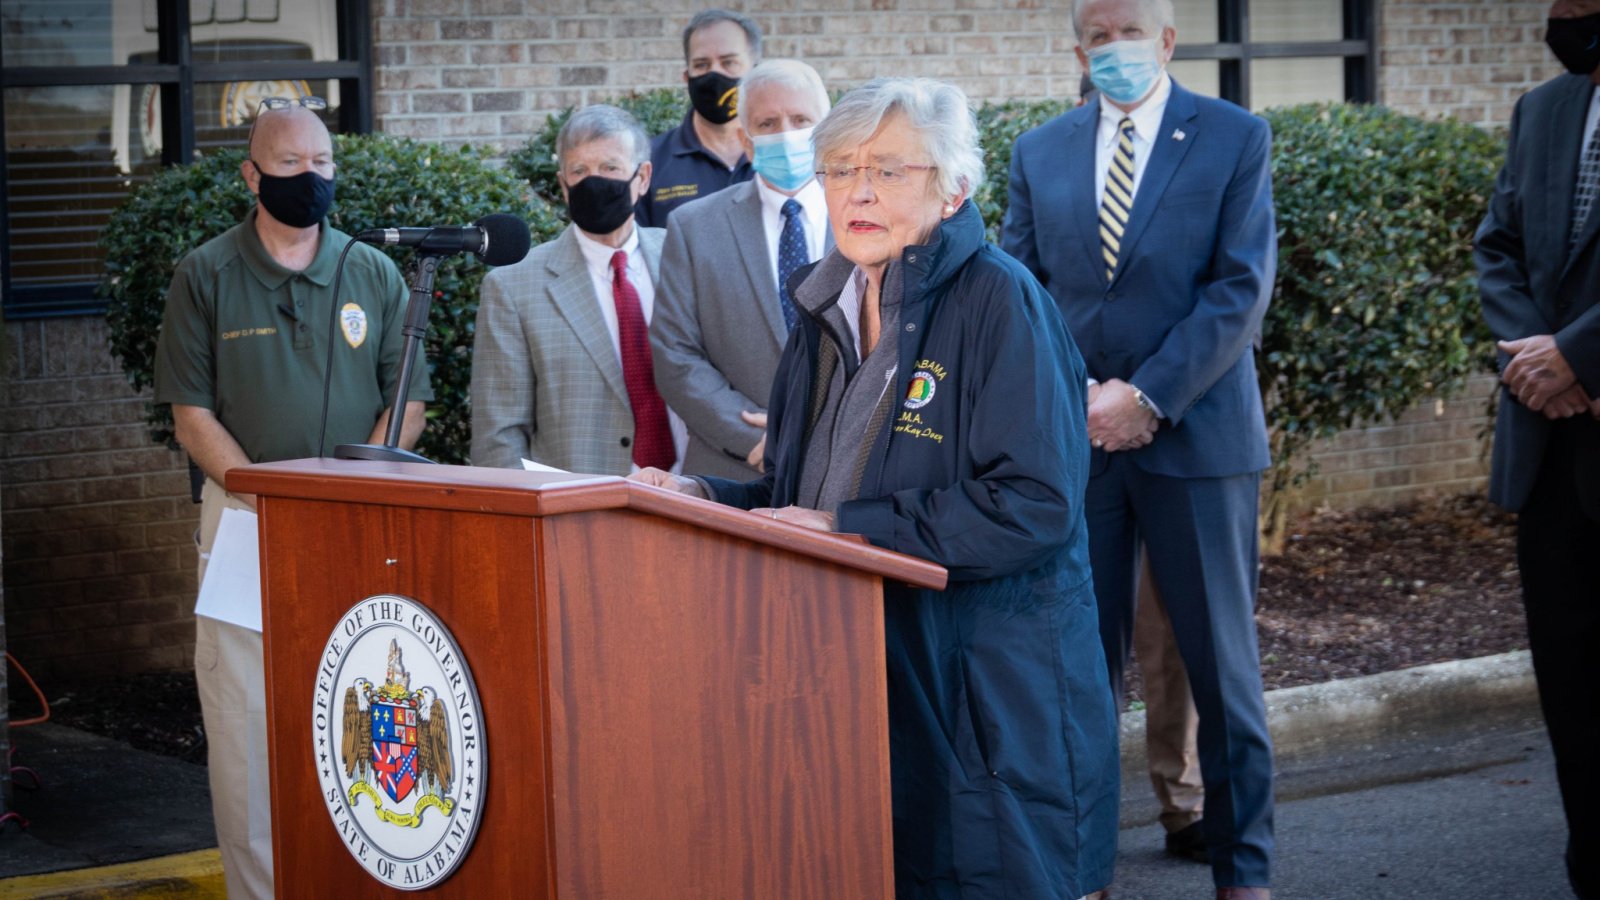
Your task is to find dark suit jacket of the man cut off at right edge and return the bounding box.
[1474,75,1600,517]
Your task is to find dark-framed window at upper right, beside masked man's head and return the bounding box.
[1170,0,1378,109]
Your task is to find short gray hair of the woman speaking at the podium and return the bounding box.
[811,78,984,197]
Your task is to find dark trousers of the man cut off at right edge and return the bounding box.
[1517,423,1600,898]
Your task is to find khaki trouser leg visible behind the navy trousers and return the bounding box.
[1133,556,1205,833]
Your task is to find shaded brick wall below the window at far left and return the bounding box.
[0,317,197,672]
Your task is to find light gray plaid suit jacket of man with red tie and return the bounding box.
[472,226,666,476]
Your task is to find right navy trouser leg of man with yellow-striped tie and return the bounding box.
[1139,472,1274,887]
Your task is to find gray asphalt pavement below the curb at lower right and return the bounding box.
[1112,717,1573,900]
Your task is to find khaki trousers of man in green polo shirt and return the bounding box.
[195,479,272,900]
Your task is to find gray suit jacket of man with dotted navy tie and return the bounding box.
[650,179,834,480]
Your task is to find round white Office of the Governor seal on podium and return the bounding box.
[312,594,488,890]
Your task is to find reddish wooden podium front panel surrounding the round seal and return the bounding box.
[261,498,555,900]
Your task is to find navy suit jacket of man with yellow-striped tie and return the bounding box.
[1000,80,1277,477]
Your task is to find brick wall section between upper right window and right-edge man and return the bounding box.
[1378,0,1562,125]
